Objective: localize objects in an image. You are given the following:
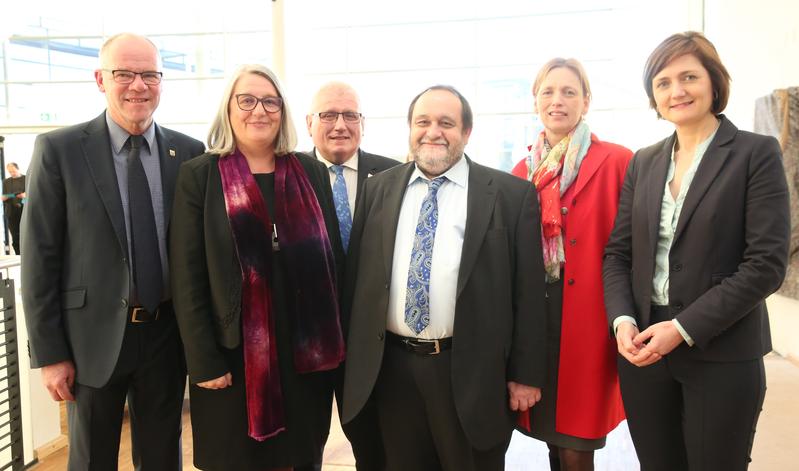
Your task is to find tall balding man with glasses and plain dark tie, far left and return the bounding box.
[22,33,204,471]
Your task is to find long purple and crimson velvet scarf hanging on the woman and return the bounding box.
[219,149,344,441]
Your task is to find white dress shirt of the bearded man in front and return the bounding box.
[386,157,469,339]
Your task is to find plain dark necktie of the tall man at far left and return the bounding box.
[128,136,163,312]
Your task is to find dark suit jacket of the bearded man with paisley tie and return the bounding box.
[343,161,546,449]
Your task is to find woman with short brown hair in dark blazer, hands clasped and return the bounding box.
[603,32,790,471]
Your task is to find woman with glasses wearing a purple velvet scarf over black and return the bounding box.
[170,65,344,471]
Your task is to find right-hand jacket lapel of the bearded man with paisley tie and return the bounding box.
[457,157,497,296]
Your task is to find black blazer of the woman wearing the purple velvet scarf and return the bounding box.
[170,153,343,383]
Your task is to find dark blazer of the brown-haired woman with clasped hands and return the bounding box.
[603,115,790,361]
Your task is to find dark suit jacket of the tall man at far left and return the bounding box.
[21,112,204,387]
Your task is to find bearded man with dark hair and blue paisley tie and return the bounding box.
[342,85,546,471]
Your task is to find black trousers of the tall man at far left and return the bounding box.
[67,307,186,471]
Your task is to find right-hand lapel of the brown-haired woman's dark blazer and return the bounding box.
[672,118,738,246]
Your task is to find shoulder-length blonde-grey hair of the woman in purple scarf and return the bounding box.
[207,64,297,156]
